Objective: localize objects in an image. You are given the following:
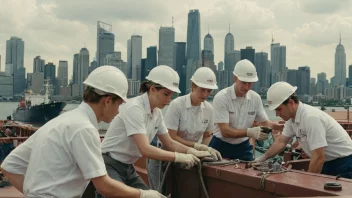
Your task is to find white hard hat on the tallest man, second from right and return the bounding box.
[233,59,258,82]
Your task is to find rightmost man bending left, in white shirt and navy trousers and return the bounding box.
[256,82,352,178]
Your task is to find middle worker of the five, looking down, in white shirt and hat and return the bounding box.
[148,67,222,190]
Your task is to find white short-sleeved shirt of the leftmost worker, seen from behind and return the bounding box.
[1,103,106,197]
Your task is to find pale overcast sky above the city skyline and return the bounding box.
[0,0,352,79]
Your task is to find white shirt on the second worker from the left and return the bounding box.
[101,93,168,164]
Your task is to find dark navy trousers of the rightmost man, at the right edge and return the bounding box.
[321,155,352,179]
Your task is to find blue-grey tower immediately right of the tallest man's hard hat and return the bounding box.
[254,52,270,93]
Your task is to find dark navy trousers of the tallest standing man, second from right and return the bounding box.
[209,136,254,161]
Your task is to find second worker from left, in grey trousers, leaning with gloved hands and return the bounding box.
[98,65,211,197]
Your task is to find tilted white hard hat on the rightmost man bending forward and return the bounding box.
[266,82,297,110]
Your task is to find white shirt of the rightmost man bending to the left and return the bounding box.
[282,102,352,161]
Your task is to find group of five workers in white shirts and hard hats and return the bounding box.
[1,60,352,198]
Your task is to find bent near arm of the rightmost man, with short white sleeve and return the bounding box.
[301,116,328,173]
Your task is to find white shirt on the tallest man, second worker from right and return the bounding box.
[213,84,268,144]
